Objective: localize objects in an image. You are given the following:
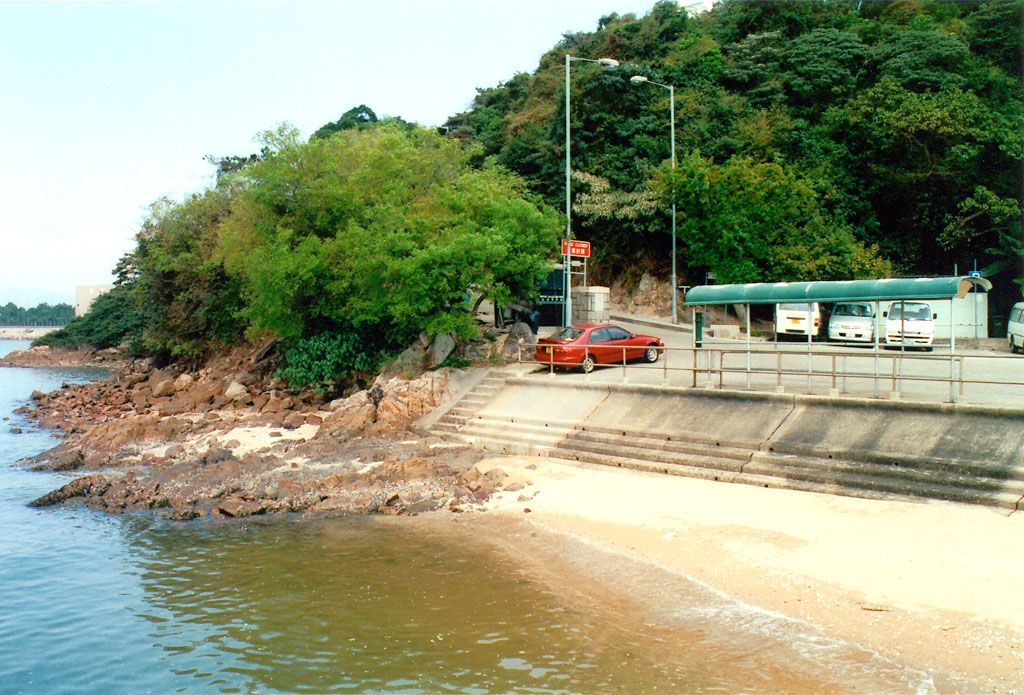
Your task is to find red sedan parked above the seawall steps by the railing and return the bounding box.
[534,323,665,374]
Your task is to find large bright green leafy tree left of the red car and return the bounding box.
[218,125,561,381]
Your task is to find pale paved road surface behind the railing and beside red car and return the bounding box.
[536,320,1024,407]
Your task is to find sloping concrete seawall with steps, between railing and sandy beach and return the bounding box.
[432,377,1024,510]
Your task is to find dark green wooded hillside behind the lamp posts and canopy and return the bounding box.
[450,0,1024,307]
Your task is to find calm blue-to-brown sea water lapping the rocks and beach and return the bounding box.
[0,341,929,693]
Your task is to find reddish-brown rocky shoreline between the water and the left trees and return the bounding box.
[4,341,523,520]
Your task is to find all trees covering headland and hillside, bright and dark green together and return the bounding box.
[43,0,1024,386]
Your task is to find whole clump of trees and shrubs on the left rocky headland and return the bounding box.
[41,123,561,386]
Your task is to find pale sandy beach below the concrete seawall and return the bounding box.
[468,458,1024,693]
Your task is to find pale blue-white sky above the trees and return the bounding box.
[0,0,704,307]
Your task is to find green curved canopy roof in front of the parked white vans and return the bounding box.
[684,275,992,306]
